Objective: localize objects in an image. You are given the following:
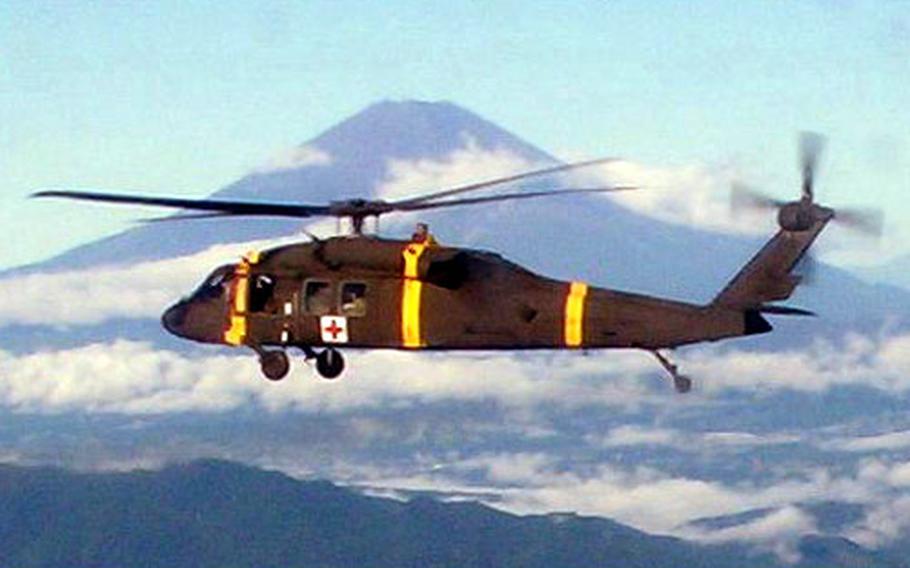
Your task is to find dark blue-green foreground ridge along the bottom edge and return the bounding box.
[0,460,893,568]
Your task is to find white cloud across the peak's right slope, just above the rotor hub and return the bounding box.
[376,137,546,200]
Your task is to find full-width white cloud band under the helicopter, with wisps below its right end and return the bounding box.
[8,328,910,418]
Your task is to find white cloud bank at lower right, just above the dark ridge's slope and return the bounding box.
[336,452,910,561]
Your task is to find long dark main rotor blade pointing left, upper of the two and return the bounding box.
[32,190,331,217]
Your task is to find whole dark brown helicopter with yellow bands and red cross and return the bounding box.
[34,135,875,392]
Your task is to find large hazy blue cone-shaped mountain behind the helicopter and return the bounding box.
[14,101,910,328]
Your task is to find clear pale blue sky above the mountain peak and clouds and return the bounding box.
[0,0,910,268]
